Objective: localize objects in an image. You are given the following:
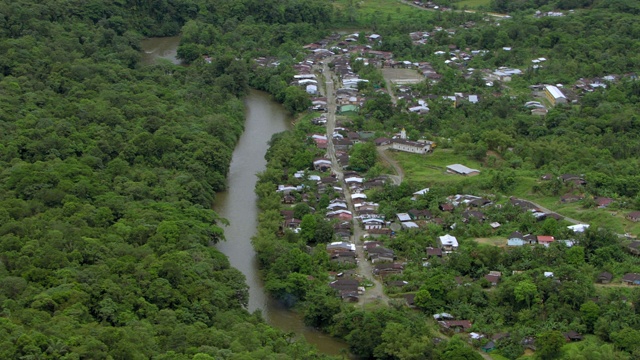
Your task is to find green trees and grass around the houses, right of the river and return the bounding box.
[191,2,640,359]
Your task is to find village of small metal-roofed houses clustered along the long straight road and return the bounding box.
[249,28,640,352]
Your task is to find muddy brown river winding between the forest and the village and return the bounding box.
[142,37,347,355]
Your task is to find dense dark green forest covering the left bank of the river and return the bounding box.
[0,0,340,359]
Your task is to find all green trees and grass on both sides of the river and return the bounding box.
[0,0,640,359]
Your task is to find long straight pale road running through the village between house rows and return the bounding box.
[322,59,389,306]
